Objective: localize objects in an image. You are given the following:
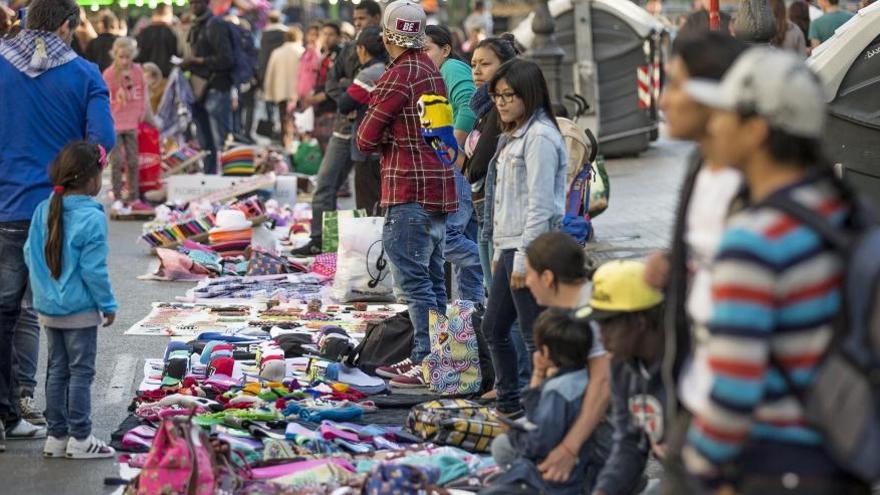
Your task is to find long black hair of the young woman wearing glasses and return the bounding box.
[489,58,559,132]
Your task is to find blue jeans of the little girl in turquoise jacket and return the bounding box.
[46,327,98,440]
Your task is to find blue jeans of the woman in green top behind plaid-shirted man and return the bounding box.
[443,169,486,304]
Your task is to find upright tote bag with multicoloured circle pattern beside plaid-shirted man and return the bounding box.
[422,301,483,395]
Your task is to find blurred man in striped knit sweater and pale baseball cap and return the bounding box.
[682,48,878,495]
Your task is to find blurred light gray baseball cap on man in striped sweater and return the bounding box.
[685,47,826,138]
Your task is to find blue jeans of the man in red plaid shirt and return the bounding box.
[382,203,446,363]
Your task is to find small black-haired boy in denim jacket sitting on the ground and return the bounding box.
[492,309,610,495]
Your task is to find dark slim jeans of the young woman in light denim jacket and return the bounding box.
[483,249,543,409]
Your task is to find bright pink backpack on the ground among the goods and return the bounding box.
[131,417,218,495]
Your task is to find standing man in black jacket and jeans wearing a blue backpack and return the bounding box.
[181,0,236,174]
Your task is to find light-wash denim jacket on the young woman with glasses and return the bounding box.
[483,110,568,273]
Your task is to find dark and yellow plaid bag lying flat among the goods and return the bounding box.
[406,399,501,452]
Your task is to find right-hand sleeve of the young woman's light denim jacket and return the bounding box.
[513,131,559,273]
